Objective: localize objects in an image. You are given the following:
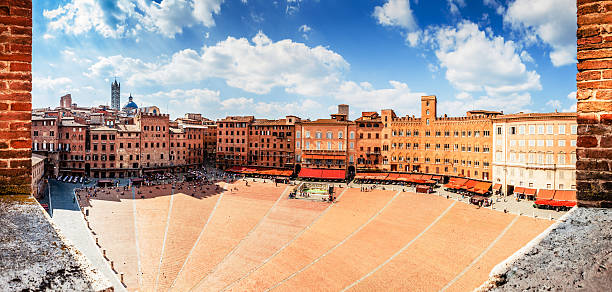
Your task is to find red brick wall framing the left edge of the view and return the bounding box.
[0,0,32,195]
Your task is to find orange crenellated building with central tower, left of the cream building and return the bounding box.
[381,96,502,180]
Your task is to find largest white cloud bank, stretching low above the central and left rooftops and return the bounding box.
[86,32,436,118]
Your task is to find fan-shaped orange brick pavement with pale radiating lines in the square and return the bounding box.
[81,181,552,292]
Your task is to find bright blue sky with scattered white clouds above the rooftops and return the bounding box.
[33,0,576,119]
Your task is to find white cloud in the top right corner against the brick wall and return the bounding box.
[504,0,576,67]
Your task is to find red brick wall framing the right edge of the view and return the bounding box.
[576,0,612,207]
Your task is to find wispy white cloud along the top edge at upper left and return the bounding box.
[43,0,224,38]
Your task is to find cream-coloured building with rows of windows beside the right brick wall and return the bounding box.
[493,112,577,194]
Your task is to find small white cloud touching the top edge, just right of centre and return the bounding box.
[372,0,418,31]
